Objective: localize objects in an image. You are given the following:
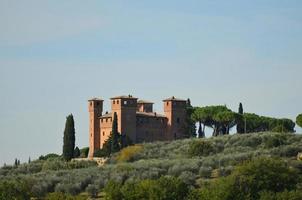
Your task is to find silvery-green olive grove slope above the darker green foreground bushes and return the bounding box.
[0,133,302,199]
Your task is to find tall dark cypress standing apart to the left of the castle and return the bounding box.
[63,114,75,161]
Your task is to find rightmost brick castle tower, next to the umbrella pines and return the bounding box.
[163,96,186,140]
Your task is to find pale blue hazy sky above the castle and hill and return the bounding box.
[0,0,302,165]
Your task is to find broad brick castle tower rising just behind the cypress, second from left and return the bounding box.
[111,95,137,142]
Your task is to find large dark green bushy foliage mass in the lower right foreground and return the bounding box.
[200,158,298,200]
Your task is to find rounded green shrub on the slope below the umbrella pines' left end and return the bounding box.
[188,140,214,157]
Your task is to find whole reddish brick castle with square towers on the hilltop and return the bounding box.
[88,95,187,158]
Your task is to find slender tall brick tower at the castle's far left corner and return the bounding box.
[88,98,103,158]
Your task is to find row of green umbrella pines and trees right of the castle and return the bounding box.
[187,103,302,138]
